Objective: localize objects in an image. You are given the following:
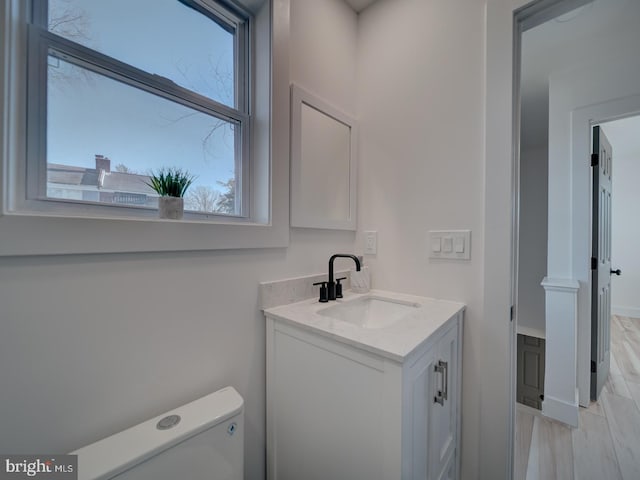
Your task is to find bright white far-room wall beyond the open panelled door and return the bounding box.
[603,141,640,318]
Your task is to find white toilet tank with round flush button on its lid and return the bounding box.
[71,387,244,480]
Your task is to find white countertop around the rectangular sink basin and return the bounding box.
[264,290,465,362]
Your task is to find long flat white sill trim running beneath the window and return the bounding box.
[0,209,289,256]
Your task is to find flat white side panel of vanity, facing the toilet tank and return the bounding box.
[268,325,392,480]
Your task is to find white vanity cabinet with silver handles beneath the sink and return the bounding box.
[265,292,464,480]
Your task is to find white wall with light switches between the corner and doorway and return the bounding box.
[357,0,486,478]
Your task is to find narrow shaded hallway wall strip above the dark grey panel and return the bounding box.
[518,147,549,337]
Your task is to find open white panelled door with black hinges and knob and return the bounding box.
[591,127,619,400]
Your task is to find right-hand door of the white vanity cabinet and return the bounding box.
[429,326,458,480]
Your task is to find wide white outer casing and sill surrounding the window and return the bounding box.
[0,0,290,256]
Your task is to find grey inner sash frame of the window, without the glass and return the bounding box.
[28,0,251,221]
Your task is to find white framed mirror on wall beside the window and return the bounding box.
[291,85,358,230]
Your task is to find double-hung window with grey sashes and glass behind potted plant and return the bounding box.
[25,0,251,220]
